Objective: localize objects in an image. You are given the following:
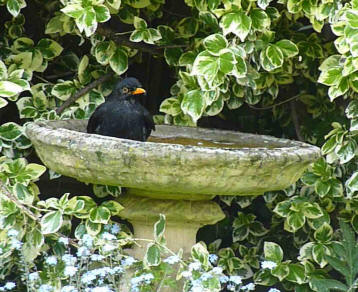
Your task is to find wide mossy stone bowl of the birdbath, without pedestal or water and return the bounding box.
[26,120,320,200]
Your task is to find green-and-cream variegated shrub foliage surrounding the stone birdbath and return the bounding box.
[0,0,358,292]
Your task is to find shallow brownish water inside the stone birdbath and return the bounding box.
[147,136,276,149]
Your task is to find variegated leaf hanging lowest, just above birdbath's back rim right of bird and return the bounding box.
[180,89,206,122]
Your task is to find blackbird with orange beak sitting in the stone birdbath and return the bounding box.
[87,77,155,141]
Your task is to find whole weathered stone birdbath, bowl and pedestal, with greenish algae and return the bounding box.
[26,120,320,257]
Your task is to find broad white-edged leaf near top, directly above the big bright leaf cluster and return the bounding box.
[220,11,252,42]
